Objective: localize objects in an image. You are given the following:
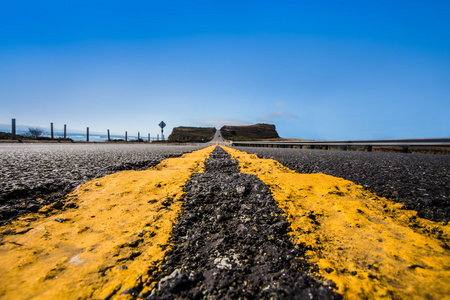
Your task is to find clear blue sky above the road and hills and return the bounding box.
[0,0,450,139]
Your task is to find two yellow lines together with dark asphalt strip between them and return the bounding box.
[0,145,450,299]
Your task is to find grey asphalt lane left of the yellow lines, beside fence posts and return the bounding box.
[0,143,205,225]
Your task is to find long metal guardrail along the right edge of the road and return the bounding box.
[231,138,450,153]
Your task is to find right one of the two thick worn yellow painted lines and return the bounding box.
[224,147,450,299]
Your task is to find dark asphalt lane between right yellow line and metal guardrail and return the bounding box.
[236,147,450,222]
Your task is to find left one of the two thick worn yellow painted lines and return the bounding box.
[0,147,214,299]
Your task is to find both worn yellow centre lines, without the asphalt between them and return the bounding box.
[0,146,450,299]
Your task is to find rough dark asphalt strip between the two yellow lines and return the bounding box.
[145,147,342,299]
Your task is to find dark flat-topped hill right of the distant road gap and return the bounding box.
[220,124,279,141]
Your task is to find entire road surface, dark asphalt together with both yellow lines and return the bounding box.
[0,144,450,300]
